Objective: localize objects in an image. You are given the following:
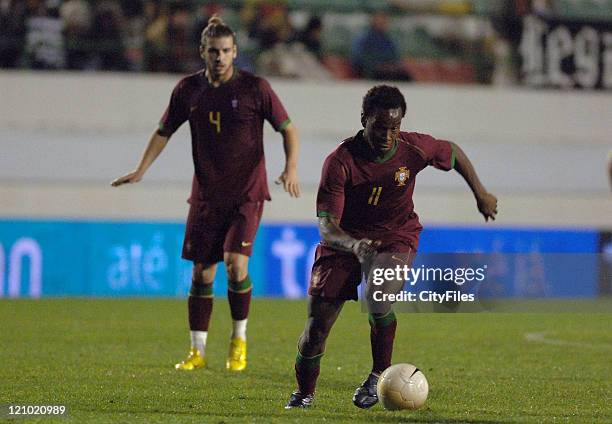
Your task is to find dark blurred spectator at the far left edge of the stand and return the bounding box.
[0,0,26,68]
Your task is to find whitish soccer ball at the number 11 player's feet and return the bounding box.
[376,364,429,410]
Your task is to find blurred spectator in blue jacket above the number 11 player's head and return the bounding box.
[351,11,412,81]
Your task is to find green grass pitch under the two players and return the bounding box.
[0,299,612,423]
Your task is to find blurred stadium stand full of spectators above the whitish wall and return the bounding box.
[0,0,612,84]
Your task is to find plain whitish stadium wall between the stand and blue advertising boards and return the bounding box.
[0,71,612,227]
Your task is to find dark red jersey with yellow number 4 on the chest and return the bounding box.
[158,70,290,204]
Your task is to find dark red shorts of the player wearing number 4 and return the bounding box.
[182,201,263,264]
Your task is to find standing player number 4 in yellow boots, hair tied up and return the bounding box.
[112,16,300,371]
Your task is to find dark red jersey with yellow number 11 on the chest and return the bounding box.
[317,131,455,250]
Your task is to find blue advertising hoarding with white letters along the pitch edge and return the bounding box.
[0,219,599,298]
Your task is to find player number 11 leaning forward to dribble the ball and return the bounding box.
[286,85,497,409]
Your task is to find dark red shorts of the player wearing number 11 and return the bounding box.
[308,242,416,300]
